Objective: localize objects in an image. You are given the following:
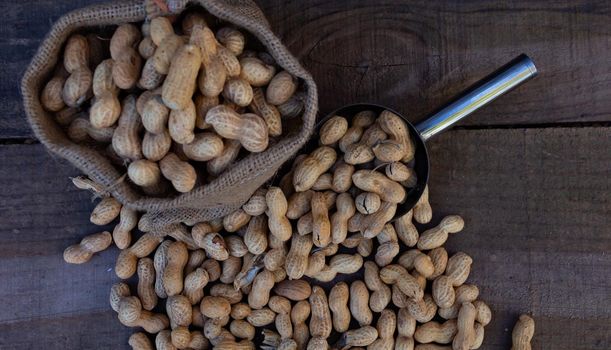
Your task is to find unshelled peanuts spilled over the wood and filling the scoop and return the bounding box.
[64,106,534,350]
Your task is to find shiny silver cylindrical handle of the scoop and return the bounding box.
[416,54,537,141]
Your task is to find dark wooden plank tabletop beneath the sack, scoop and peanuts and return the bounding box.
[0,0,611,350]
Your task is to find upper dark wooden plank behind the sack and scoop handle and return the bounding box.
[0,0,611,138]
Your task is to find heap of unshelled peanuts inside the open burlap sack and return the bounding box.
[40,12,304,196]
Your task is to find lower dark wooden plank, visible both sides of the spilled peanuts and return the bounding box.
[0,128,611,350]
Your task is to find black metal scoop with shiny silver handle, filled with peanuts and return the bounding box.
[305,54,537,220]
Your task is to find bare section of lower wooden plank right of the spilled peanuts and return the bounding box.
[429,128,611,349]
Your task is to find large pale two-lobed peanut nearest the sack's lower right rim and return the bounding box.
[206,105,269,153]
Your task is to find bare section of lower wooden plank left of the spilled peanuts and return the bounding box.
[0,145,131,349]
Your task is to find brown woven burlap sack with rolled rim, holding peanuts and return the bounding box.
[21,0,318,230]
